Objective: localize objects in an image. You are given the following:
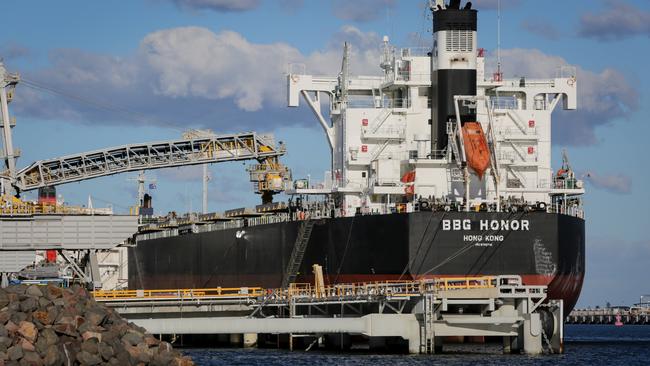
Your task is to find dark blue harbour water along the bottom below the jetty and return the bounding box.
[184,325,650,366]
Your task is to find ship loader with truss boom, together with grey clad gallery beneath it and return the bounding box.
[0,61,291,288]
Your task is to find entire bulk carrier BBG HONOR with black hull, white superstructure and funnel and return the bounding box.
[128,0,585,313]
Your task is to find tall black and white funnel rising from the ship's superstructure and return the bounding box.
[431,1,477,158]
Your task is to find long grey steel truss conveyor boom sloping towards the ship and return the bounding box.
[15,132,286,191]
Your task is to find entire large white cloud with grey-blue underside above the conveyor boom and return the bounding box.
[14,26,380,131]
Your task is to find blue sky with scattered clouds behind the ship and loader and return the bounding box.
[0,0,650,306]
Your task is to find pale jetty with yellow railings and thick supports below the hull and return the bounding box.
[93,276,563,354]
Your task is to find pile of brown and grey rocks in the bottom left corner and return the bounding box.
[0,285,194,366]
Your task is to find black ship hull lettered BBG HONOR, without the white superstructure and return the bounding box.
[129,212,585,313]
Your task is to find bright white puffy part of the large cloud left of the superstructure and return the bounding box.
[141,26,379,111]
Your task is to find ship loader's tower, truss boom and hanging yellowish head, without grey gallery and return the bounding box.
[0,63,291,203]
